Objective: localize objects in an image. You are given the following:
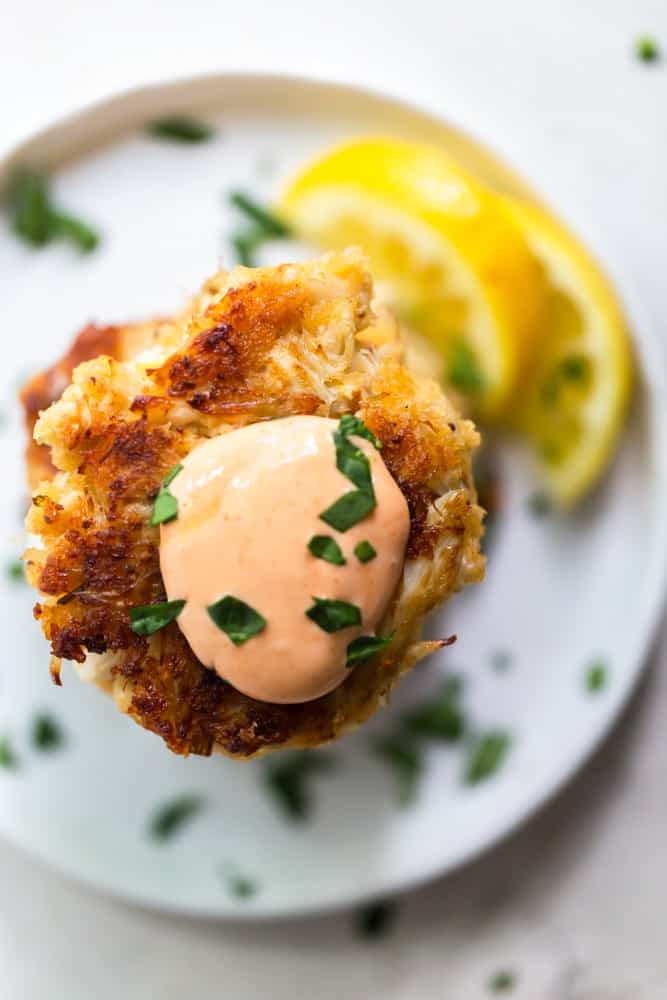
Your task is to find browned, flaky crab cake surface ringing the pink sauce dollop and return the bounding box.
[24,252,483,757]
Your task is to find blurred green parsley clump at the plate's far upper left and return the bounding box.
[9,167,99,253]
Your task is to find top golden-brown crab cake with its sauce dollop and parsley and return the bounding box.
[24,250,484,758]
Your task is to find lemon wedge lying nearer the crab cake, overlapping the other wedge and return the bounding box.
[278,138,544,419]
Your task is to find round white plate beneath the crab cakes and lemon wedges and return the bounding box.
[0,76,667,917]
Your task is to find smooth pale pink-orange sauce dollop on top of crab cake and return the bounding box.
[160,416,410,704]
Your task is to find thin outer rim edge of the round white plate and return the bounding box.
[0,70,667,922]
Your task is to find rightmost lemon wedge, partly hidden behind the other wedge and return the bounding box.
[503,198,633,506]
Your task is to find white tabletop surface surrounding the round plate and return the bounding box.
[0,0,667,1000]
